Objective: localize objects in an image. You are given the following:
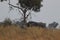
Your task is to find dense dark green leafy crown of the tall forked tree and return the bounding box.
[19,0,43,11]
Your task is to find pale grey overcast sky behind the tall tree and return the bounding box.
[0,0,60,24]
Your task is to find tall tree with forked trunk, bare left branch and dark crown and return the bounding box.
[1,0,43,24]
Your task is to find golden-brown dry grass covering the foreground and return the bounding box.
[0,25,60,40]
